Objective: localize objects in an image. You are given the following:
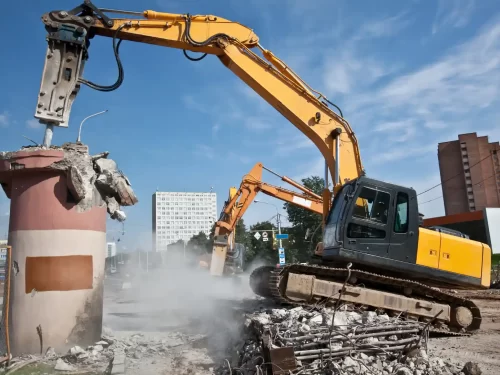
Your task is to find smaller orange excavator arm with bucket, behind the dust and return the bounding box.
[210,163,323,275]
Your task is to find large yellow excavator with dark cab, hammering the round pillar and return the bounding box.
[35,0,491,335]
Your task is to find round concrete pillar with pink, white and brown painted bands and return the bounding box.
[0,150,106,355]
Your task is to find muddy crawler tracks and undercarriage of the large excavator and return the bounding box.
[250,264,481,335]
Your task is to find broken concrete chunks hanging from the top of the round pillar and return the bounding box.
[0,143,138,221]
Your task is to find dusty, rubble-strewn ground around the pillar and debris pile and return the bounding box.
[1,268,500,375]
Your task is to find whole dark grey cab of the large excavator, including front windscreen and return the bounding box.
[323,176,419,267]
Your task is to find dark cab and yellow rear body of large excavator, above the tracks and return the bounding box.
[322,176,491,288]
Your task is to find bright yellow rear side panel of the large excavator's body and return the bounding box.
[417,228,491,286]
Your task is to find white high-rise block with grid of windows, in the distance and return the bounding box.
[152,191,217,251]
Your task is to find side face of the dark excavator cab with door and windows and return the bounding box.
[330,177,418,263]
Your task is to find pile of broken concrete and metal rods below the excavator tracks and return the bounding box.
[217,307,473,375]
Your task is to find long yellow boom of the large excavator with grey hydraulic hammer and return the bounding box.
[35,0,364,203]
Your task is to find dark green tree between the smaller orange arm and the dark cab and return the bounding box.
[284,176,325,263]
